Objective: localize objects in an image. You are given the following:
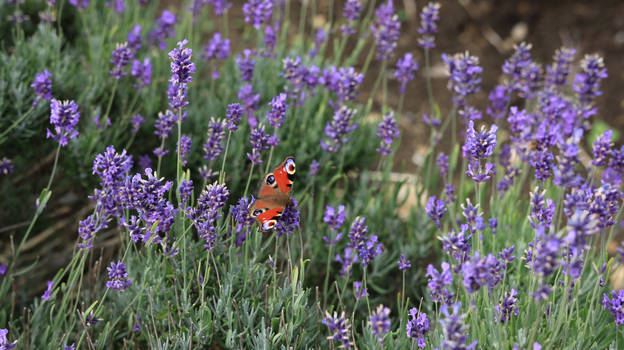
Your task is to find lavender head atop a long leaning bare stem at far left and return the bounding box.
[46,98,80,147]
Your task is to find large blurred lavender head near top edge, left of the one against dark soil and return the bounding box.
[371,0,401,61]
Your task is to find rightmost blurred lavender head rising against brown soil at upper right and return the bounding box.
[572,54,607,105]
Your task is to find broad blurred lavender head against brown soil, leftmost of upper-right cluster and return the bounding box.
[442,52,483,106]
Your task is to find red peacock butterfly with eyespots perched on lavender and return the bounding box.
[248,156,295,231]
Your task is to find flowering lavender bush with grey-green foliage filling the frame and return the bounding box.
[0,0,624,349]
